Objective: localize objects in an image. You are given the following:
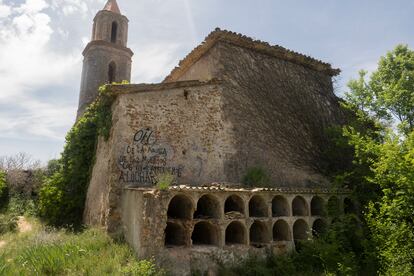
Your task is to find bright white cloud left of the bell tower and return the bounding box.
[0,0,81,140]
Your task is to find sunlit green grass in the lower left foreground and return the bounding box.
[0,223,164,276]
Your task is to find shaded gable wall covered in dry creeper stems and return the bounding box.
[174,42,342,186]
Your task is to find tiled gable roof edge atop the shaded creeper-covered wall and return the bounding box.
[164,28,341,82]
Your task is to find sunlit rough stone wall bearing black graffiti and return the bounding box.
[84,81,235,233]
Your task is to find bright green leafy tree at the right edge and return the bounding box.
[343,45,414,275]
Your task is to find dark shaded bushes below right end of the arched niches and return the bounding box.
[220,215,376,276]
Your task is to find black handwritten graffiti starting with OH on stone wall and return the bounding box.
[118,128,183,185]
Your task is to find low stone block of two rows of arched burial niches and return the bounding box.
[122,184,352,275]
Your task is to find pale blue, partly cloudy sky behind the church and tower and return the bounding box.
[0,0,414,162]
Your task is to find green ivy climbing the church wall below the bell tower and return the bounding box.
[39,86,114,227]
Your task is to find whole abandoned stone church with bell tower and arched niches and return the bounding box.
[78,0,353,275]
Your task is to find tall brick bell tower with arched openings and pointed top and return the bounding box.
[77,0,134,118]
